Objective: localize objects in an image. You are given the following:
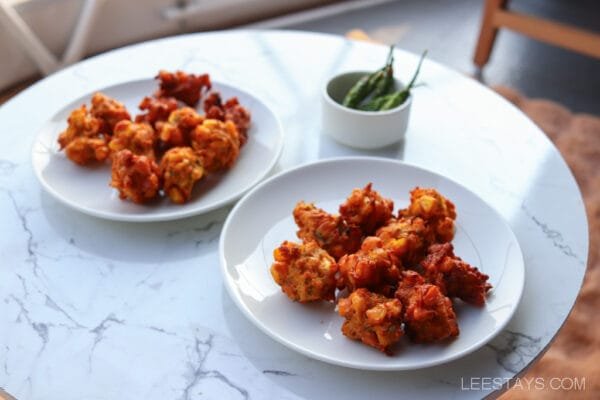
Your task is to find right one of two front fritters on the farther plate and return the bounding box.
[160,147,204,204]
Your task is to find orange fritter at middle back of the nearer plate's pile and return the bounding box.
[340,183,394,236]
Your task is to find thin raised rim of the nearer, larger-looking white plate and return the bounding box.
[219,156,526,372]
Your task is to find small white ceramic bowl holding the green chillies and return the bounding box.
[321,71,412,149]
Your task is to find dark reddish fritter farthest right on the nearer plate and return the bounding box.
[422,243,492,306]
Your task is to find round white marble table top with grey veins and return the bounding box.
[0,31,588,400]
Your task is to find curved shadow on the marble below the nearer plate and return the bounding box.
[222,290,506,400]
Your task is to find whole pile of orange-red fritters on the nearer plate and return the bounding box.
[271,183,491,354]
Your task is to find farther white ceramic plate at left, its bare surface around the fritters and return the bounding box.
[32,79,283,222]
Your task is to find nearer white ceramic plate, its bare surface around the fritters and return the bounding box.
[219,158,524,370]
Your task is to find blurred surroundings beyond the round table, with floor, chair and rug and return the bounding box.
[0,0,600,400]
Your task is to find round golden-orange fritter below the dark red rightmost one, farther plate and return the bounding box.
[191,119,240,172]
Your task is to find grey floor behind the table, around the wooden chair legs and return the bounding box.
[286,0,600,115]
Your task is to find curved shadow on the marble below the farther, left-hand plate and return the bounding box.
[40,191,231,263]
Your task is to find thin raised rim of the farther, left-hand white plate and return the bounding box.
[29,77,285,223]
